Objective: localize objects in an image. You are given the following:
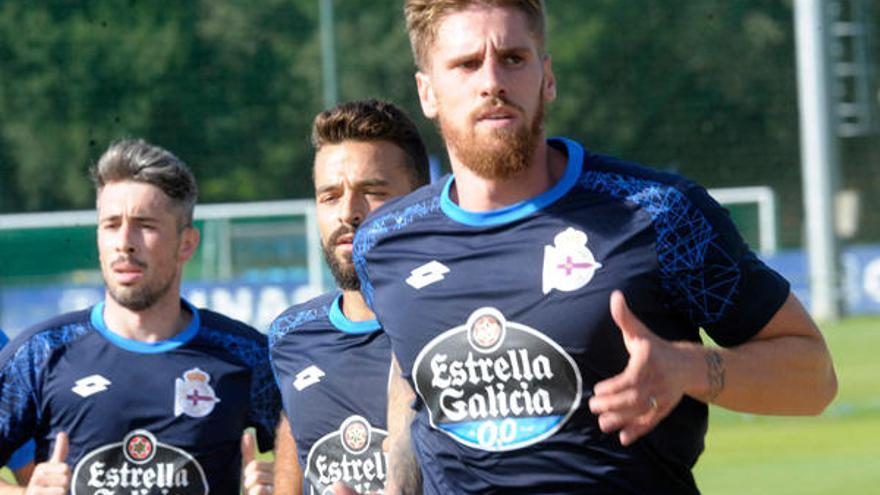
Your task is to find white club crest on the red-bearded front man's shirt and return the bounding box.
[544,227,602,294]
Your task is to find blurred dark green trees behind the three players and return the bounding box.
[0,0,880,245]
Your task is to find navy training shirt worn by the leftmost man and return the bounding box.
[0,301,280,495]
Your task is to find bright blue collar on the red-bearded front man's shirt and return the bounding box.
[440,138,584,227]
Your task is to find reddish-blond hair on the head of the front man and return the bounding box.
[403,0,546,70]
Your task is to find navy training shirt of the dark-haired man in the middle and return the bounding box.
[269,291,391,495]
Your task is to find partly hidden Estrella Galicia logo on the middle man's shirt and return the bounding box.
[306,415,388,495]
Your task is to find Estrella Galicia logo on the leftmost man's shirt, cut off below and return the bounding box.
[71,430,208,495]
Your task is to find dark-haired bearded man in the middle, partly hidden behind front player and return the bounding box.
[269,100,428,494]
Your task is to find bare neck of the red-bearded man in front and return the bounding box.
[450,139,567,212]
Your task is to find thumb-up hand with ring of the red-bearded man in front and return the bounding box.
[590,291,687,445]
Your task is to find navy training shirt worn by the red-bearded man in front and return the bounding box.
[354,139,789,495]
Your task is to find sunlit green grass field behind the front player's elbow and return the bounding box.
[2,317,880,495]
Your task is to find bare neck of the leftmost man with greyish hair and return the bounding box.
[104,290,193,343]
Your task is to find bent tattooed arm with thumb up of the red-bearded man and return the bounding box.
[590,292,837,444]
